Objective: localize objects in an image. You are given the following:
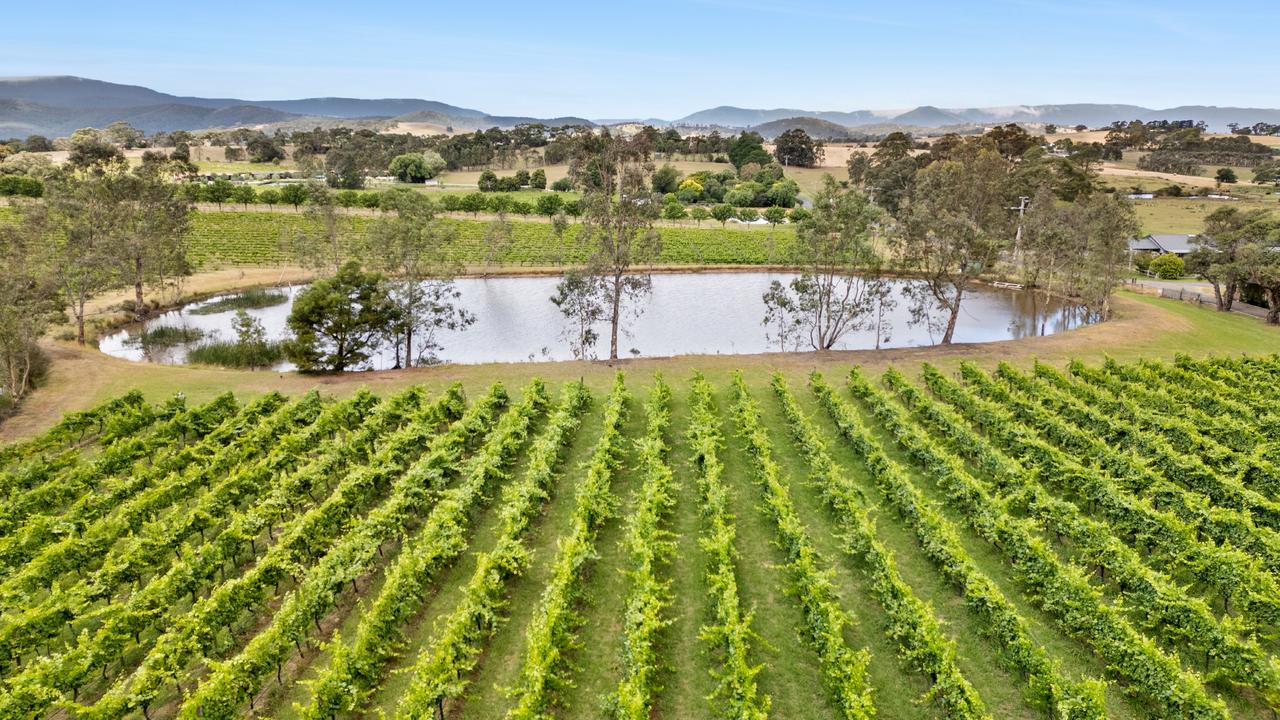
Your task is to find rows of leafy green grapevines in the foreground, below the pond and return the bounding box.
[0,353,1280,720]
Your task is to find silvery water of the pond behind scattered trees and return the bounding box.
[99,272,1092,370]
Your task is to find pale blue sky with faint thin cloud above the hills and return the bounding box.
[0,0,1280,118]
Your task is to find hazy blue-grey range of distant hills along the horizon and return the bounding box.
[0,76,1280,138]
